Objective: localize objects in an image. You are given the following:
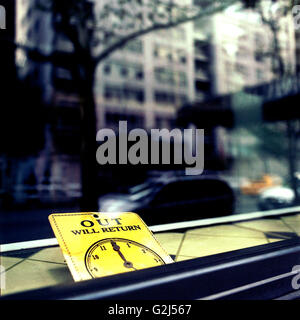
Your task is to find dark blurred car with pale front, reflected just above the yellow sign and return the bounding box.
[99,177,235,225]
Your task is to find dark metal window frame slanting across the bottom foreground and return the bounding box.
[0,238,300,300]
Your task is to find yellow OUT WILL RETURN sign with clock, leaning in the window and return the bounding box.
[49,212,173,281]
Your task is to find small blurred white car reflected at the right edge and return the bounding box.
[257,186,296,210]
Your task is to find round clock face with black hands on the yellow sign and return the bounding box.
[85,238,165,278]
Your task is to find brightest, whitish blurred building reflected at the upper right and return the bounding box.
[194,7,295,96]
